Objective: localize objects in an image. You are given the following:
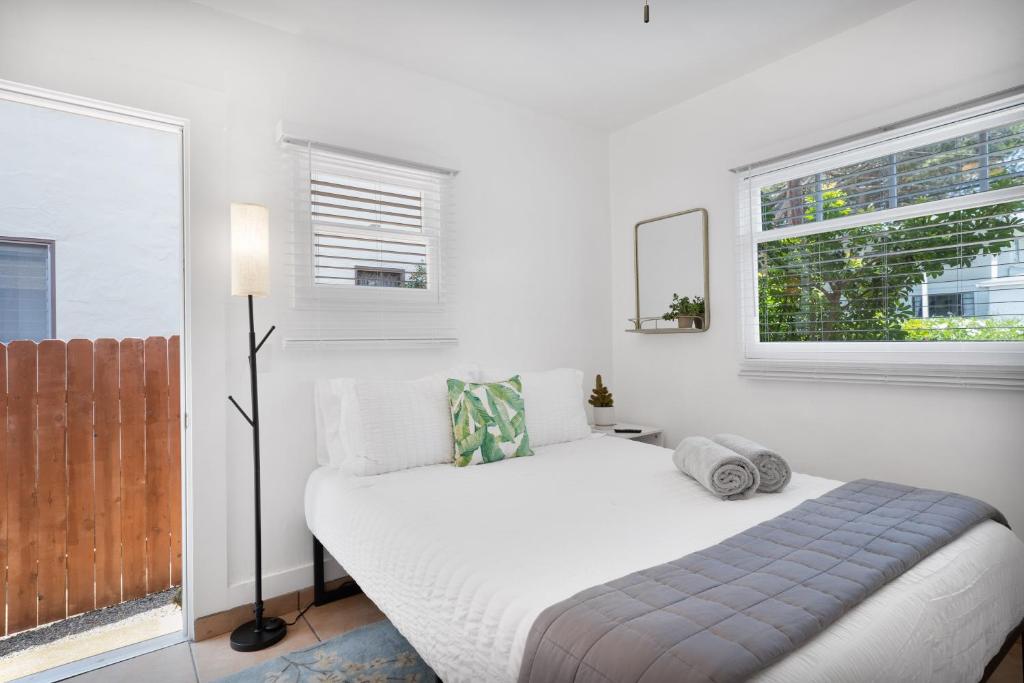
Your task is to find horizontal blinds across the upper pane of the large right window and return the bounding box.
[760,121,1024,230]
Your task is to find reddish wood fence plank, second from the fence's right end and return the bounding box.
[145,337,171,593]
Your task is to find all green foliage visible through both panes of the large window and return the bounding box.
[758,122,1024,341]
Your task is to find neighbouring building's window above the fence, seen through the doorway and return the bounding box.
[0,239,55,343]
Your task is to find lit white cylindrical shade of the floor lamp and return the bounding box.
[231,204,270,296]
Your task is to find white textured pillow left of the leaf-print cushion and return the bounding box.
[315,367,477,475]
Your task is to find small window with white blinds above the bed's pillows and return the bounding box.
[286,139,456,345]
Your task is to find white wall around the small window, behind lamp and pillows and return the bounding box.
[0,0,611,614]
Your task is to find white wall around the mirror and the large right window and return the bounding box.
[610,0,1024,529]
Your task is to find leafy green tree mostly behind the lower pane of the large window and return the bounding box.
[758,191,1024,341]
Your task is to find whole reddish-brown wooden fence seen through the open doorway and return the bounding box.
[0,336,181,634]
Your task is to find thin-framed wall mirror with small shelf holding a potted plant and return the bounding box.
[627,209,711,334]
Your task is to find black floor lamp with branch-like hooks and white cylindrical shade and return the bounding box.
[227,204,288,652]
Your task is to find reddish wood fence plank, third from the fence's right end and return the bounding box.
[120,339,146,600]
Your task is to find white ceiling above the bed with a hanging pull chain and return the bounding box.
[196,0,909,129]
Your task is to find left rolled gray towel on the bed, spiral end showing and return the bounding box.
[672,436,761,501]
